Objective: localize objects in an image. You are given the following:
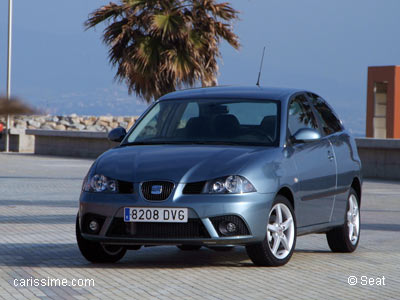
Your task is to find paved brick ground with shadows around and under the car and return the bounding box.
[0,154,400,299]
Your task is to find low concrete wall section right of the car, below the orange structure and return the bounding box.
[356,138,400,180]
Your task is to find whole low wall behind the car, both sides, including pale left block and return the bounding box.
[4,129,400,180]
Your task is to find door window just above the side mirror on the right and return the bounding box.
[288,95,318,135]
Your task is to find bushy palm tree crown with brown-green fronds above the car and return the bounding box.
[85,0,239,102]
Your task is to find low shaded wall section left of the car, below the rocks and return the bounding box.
[26,129,118,158]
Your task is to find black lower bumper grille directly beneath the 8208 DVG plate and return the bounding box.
[107,218,210,239]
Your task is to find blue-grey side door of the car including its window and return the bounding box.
[288,94,336,227]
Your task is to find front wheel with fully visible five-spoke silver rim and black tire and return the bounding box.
[246,195,297,267]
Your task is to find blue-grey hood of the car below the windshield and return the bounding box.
[95,145,276,183]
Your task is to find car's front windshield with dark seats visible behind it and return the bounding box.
[123,99,279,146]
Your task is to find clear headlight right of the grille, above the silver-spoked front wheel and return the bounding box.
[207,175,257,194]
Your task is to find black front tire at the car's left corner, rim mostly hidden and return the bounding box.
[75,215,126,263]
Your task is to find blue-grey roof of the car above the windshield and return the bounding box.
[159,85,306,101]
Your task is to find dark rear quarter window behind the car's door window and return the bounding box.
[310,94,343,135]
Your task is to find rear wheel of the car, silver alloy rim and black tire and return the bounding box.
[326,188,360,253]
